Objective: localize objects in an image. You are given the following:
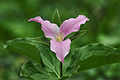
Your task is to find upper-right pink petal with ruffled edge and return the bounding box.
[60,15,89,38]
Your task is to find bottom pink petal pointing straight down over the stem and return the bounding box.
[50,39,71,62]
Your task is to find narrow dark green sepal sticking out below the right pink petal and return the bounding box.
[65,30,87,40]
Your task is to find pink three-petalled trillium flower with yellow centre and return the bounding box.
[28,15,89,62]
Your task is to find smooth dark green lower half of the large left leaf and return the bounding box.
[6,41,40,63]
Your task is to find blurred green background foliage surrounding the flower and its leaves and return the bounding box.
[0,0,120,80]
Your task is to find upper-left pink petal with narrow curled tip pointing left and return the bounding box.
[28,16,59,39]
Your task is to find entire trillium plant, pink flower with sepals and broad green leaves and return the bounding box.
[3,10,120,80]
